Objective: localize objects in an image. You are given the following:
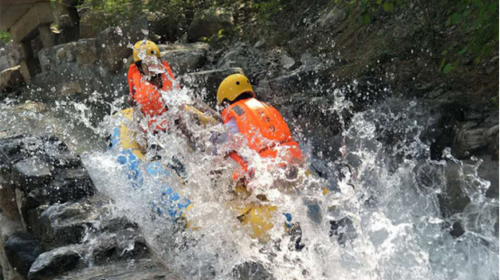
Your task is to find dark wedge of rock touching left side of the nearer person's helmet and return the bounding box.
[179,68,243,107]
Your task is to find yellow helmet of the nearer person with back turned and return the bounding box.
[217,74,255,104]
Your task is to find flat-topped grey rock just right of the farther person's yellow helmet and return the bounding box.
[160,43,210,76]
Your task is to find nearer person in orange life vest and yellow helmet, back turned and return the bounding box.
[211,74,303,190]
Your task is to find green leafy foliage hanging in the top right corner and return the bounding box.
[335,0,499,74]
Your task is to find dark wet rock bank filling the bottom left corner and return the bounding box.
[0,135,170,279]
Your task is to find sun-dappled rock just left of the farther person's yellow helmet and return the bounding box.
[96,18,148,72]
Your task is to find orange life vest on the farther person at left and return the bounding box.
[127,61,174,130]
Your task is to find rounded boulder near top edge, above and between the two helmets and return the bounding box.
[188,7,233,42]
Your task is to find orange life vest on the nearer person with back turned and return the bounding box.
[222,98,302,179]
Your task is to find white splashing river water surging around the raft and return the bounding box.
[0,77,499,279]
